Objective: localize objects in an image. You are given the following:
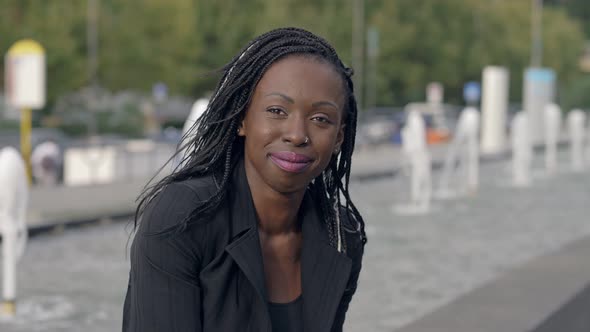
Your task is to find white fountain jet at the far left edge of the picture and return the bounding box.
[0,147,29,316]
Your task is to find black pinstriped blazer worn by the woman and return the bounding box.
[123,162,364,332]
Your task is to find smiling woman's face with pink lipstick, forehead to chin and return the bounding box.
[239,55,345,194]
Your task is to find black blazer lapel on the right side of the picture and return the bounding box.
[301,193,352,332]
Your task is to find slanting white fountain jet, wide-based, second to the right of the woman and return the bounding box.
[437,107,480,198]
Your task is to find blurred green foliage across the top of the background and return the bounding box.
[0,0,590,112]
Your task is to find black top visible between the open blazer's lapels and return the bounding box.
[268,295,303,332]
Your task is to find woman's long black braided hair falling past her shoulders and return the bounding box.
[134,28,366,252]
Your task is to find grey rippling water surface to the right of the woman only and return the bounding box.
[347,151,590,332]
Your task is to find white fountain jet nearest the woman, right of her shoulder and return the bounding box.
[396,110,432,214]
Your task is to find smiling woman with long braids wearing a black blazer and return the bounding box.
[123,28,366,332]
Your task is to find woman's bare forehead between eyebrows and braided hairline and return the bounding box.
[255,55,344,106]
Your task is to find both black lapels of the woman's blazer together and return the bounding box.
[226,161,352,331]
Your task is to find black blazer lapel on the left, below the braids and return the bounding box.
[225,161,268,302]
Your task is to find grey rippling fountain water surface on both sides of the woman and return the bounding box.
[0,147,590,332]
